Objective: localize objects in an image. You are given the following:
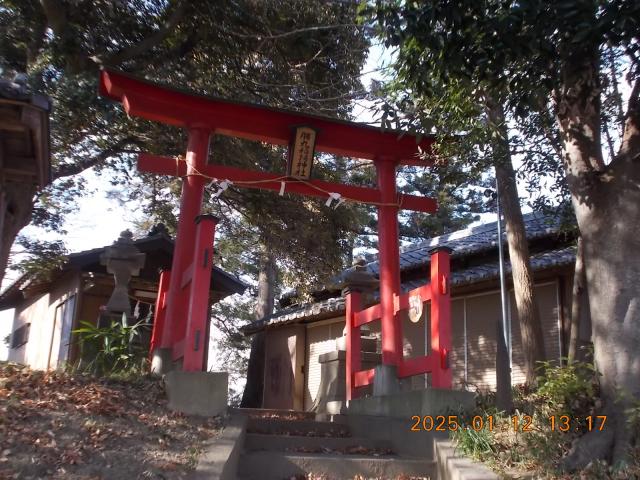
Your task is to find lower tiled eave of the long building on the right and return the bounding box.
[241,247,575,334]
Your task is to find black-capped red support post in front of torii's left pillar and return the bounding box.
[182,215,218,372]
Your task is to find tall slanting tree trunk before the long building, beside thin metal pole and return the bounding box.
[487,99,545,385]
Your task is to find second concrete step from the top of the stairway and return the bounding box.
[247,417,351,437]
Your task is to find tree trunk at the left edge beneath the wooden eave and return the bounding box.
[0,182,36,284]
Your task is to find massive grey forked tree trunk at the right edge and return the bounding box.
[555,43,640,469]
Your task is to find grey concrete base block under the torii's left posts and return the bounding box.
[165,370,229,417]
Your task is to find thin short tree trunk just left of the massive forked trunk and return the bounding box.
[568,237,591,363]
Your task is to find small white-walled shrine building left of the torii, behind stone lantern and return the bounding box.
[0,226,246,370]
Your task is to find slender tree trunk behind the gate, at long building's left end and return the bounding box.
[240,245,277,408]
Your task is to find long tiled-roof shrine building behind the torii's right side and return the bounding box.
[242,214,575,413]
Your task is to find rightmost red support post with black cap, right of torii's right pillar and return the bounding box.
[430,247,453,389]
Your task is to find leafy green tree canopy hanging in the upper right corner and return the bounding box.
[363,0,640,218]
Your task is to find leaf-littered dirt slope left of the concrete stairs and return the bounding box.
[0,363,221,480]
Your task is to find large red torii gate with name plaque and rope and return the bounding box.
[99,70,451,397]
